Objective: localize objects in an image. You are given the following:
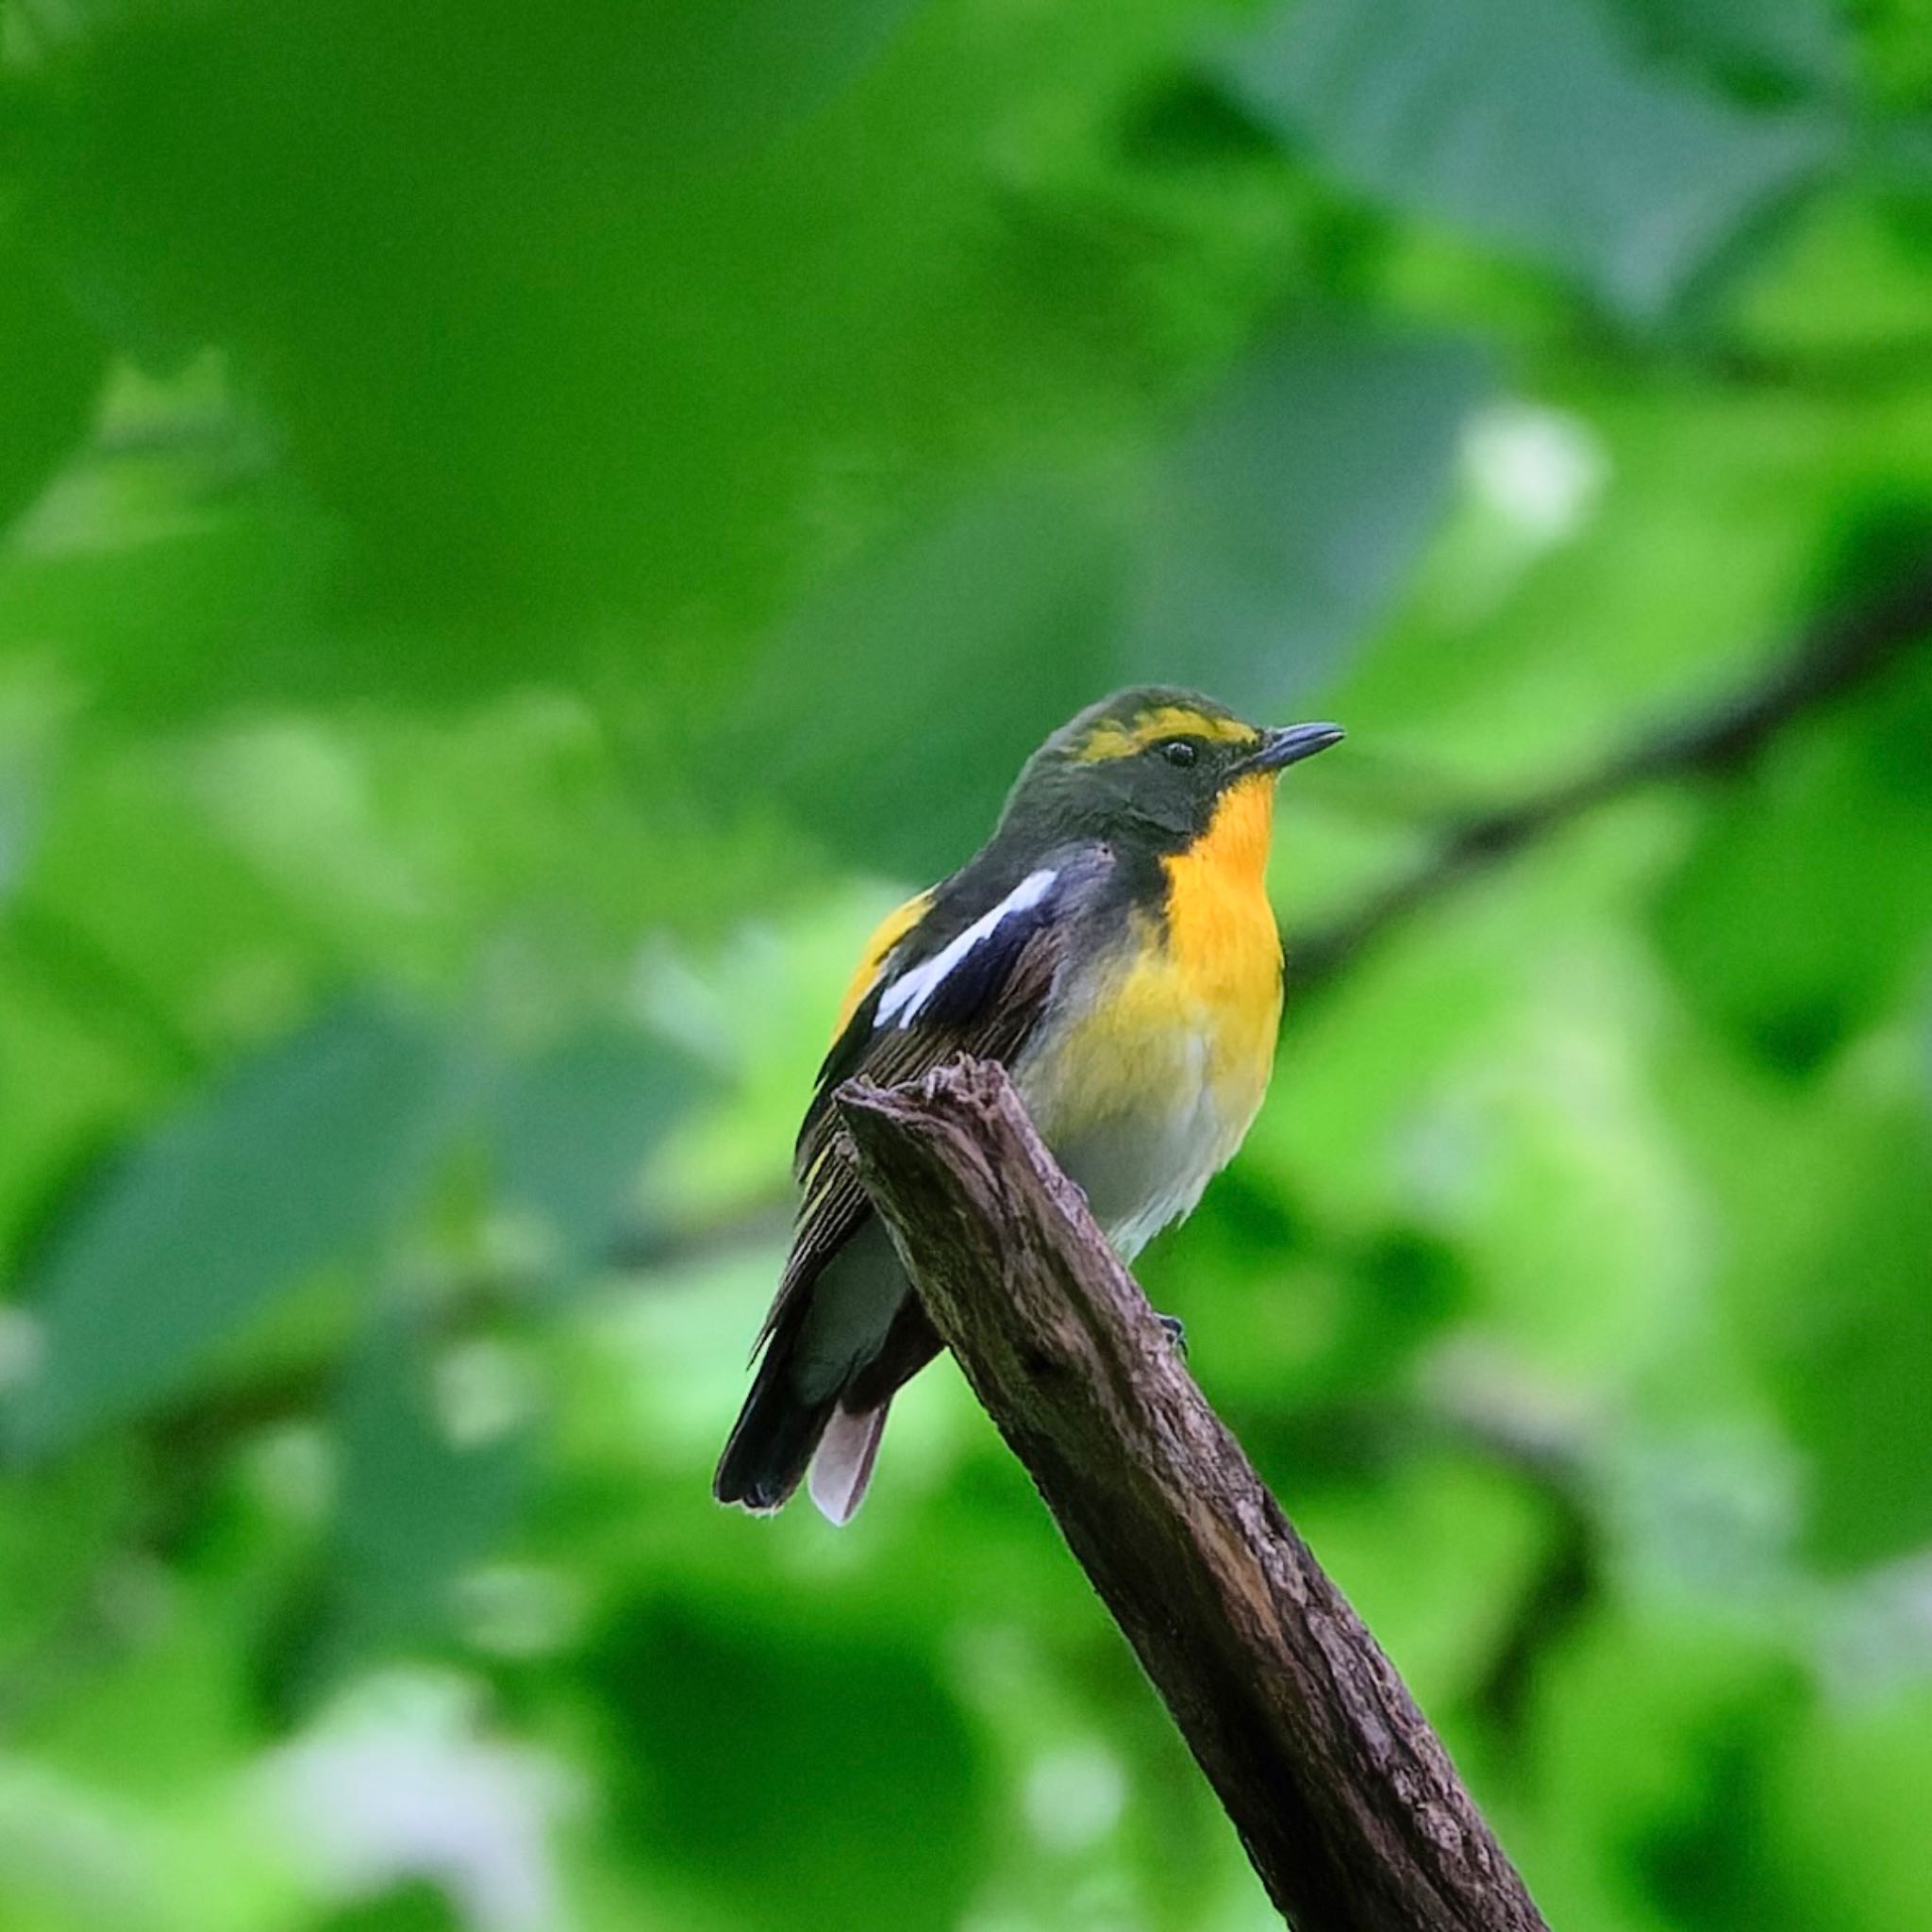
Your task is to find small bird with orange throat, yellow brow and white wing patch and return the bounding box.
[713,684,1342,1524]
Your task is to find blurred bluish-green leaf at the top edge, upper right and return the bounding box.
[1224,0,1834,323]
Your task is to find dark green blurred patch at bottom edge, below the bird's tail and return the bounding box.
[586,1606,985,1932]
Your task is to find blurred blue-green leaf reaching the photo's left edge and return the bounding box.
[9,1005,450,1451]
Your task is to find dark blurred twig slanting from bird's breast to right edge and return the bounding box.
[1292,564,1932,997]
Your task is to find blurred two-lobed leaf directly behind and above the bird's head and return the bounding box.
[749,328,1482,877]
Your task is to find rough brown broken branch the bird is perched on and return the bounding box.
[839,1060,1543,1932]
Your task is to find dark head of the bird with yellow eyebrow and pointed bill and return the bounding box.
[1001,684,1342,852]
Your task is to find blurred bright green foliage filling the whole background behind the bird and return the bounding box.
[0,0,1932,1932]
